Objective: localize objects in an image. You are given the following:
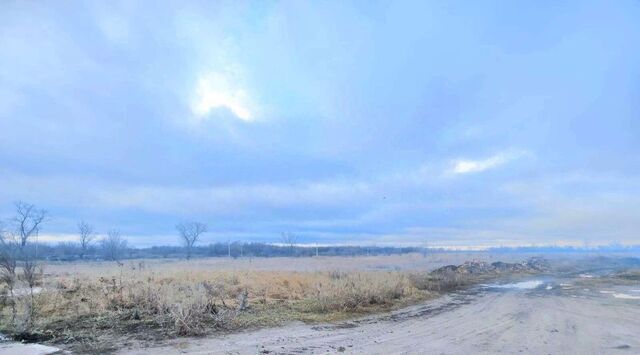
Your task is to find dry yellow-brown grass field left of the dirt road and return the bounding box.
[1,254,508,352]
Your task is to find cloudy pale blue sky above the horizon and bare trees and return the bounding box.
[0,0,640,246]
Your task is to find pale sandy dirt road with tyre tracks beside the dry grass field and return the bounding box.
[122,280,640,354]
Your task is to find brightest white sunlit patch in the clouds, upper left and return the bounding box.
[191,73,255,122]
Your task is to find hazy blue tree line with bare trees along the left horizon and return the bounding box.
[0,201,424,265]
